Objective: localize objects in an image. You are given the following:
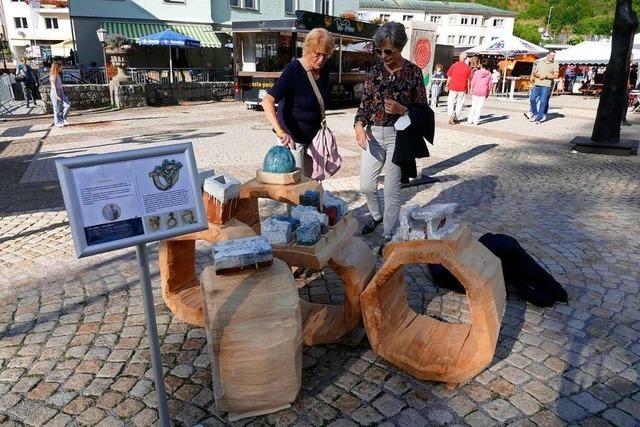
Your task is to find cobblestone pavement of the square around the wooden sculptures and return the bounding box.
[0,97,640,426]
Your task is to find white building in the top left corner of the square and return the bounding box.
[0,0,73,62]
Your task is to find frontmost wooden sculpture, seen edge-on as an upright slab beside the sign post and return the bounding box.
[201,259,302,421]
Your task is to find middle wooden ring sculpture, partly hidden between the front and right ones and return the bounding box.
[273,215,376,346]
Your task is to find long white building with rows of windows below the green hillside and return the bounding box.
[358,0,516,50]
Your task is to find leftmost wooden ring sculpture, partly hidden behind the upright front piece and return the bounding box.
[158,219,255,327]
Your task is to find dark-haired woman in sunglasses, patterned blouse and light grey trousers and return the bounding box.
[354,22,427,242]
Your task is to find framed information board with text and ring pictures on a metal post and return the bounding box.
[56,144,207,257]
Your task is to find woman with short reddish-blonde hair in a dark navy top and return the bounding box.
[262,28,335,176]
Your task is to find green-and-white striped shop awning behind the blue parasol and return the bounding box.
[100,21,226,47]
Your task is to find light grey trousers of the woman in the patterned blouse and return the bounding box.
[360,126,401,237]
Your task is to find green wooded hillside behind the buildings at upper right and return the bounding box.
[453,0,640,44]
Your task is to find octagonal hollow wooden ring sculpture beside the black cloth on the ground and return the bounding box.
[361,225,506,384]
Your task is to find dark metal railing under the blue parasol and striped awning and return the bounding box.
[129,68,233,83]
